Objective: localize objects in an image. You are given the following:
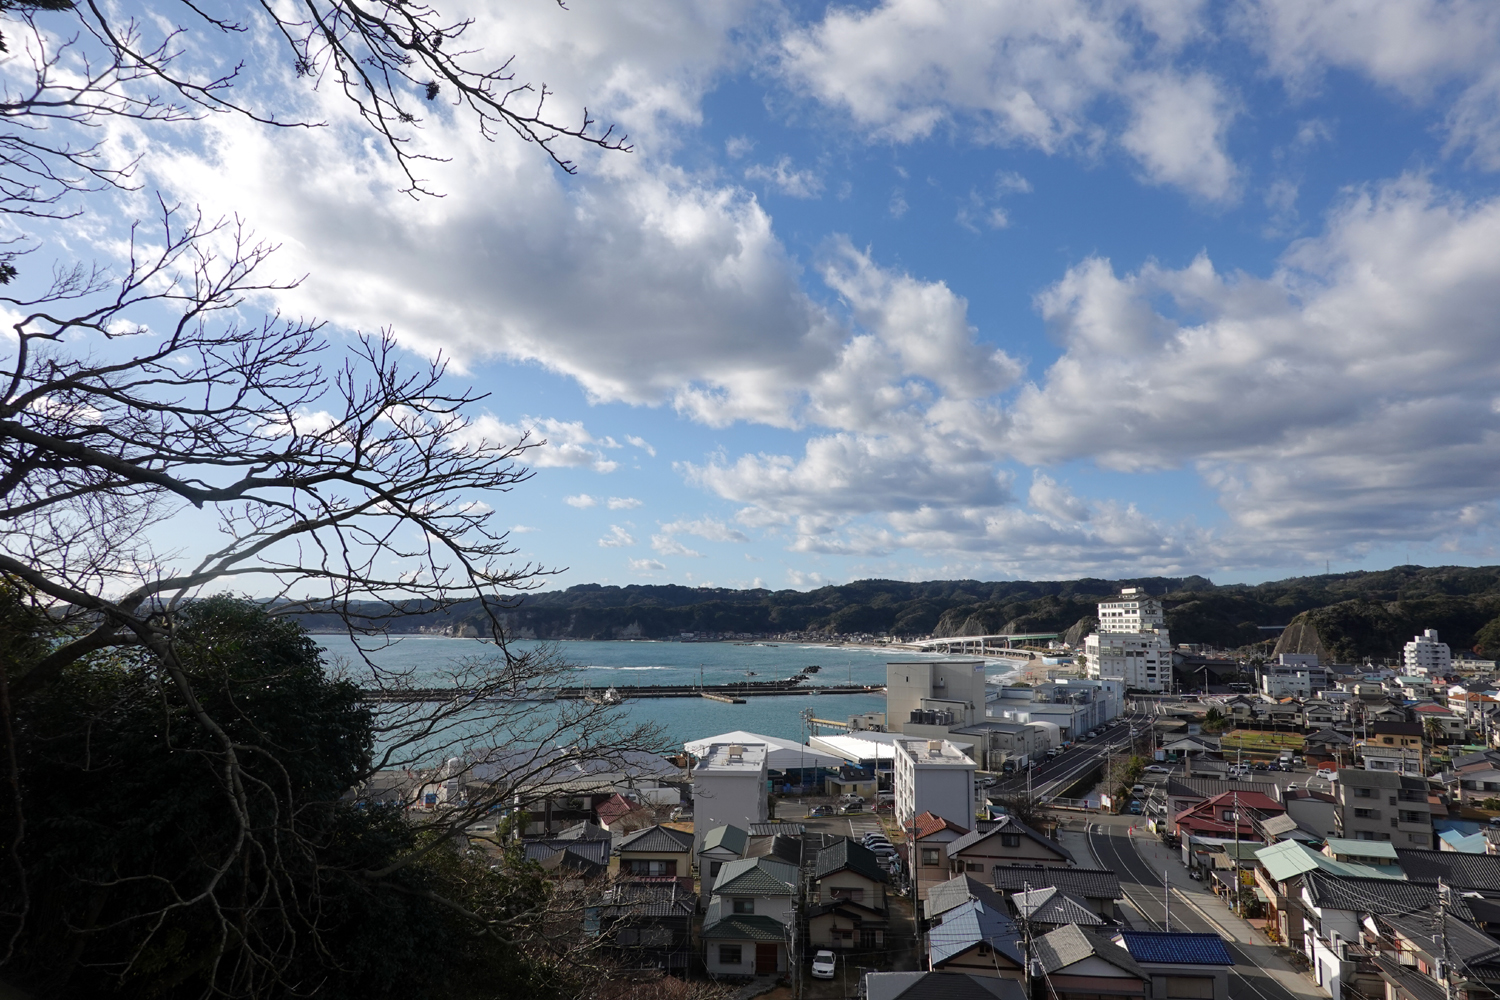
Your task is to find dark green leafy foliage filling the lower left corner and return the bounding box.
[0,598,554,999]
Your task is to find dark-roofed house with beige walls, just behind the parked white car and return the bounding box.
[807,840,888,954]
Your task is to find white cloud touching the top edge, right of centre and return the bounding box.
[782,0,1235,201]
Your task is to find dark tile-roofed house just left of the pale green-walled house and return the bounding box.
[599,881,698,975]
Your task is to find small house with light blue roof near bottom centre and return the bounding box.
[927,876,1026,981]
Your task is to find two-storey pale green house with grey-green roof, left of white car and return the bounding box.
[702,858,797,976]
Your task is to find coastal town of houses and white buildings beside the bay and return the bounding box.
[359,588,1500,1000]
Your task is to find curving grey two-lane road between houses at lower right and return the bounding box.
[1088,823,1323,1000]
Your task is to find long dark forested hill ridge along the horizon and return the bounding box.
[295,565,1500,660]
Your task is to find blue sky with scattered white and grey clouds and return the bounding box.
[23,0,1500,588]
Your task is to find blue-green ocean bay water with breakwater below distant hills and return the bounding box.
[314,636,1011,745]
